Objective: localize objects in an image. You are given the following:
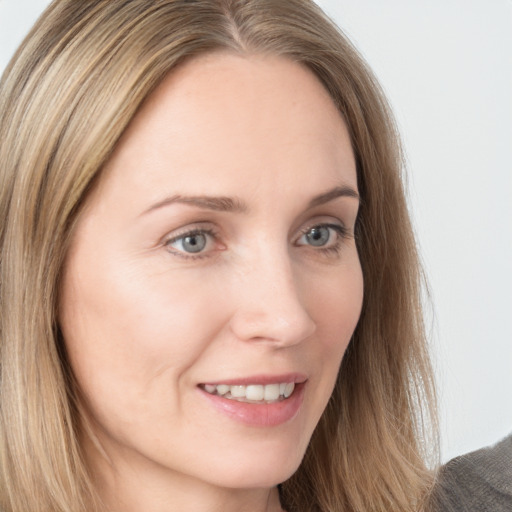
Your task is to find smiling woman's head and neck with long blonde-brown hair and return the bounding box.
[0,0,433,512]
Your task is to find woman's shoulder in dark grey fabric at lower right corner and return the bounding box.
[435,435,512,512]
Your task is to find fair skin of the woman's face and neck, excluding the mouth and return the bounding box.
[60,53,363,512]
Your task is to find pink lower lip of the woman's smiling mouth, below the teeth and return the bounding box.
[198,382,306,427]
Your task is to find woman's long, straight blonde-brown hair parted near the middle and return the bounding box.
[0,0,436,512]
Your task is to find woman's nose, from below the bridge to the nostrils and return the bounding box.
[231,249,316,347]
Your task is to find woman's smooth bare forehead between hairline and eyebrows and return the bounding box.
[96,53,357,208]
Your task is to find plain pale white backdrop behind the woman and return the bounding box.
[0,0,512,460]
